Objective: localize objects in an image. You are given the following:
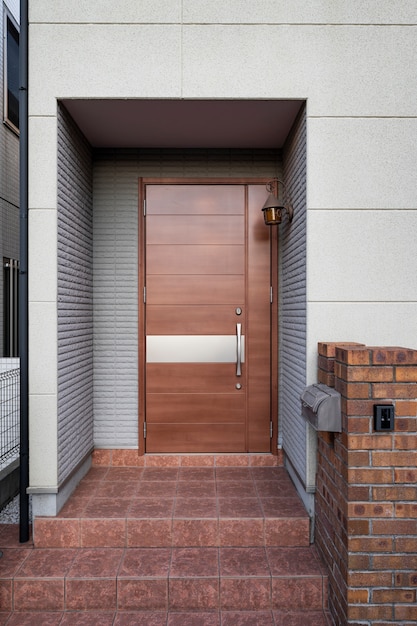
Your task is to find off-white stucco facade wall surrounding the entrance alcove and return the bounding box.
[29,0,417,494]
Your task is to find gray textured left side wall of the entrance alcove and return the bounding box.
[58,107,93,482]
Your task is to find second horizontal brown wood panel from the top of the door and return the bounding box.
[146,215,245,245]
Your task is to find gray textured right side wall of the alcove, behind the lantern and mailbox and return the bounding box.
[279,109,308,488]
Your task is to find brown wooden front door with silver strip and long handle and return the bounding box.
[142,181,271,452]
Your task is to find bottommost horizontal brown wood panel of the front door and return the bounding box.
[146,423,245,453]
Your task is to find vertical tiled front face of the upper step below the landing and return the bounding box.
[33,516,310,548]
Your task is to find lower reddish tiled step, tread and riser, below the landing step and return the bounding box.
[0,547,327,612]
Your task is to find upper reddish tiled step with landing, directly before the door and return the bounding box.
[33,458,310,548]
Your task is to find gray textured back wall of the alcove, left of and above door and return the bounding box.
[94,150,281,448]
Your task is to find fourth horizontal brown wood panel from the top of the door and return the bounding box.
[146,274,245,305]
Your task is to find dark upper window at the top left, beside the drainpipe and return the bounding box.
[4,14,19,130]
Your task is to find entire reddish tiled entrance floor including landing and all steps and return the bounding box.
[0,454,330,626]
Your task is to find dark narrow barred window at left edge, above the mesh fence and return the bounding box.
[3,258,19,357]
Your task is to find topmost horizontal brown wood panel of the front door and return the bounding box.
[146,185,245,215]
